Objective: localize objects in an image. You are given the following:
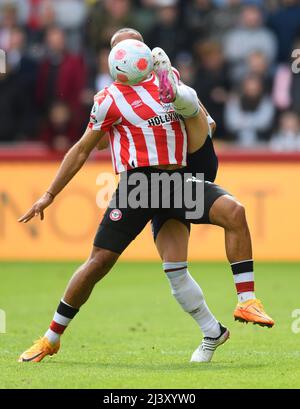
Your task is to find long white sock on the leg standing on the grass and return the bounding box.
[163,262,220,338]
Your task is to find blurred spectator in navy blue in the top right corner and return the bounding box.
[268,0,300,62]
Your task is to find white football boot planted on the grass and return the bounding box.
[190,324,230,362]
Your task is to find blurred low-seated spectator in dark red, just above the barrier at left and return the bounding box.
[40,101,79,152]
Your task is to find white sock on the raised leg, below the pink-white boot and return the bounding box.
[172,83,200,118]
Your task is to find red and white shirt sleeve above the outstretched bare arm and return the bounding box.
[88,90,120,132]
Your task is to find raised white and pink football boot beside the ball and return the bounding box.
[152,47,178,104]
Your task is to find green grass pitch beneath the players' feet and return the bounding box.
[0,262,300,389]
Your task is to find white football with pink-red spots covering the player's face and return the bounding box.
[108,39,153,85]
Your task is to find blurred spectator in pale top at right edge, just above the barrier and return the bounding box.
[270,111,300,152]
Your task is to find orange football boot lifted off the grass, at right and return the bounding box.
[233,299,275,328]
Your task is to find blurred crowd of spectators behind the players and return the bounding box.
[0,0,300,151]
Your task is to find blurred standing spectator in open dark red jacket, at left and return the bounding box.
[36,27,86,124]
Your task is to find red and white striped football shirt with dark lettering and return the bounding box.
[89,74,187,173]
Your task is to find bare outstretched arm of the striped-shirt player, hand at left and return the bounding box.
[18,128,105,223]
